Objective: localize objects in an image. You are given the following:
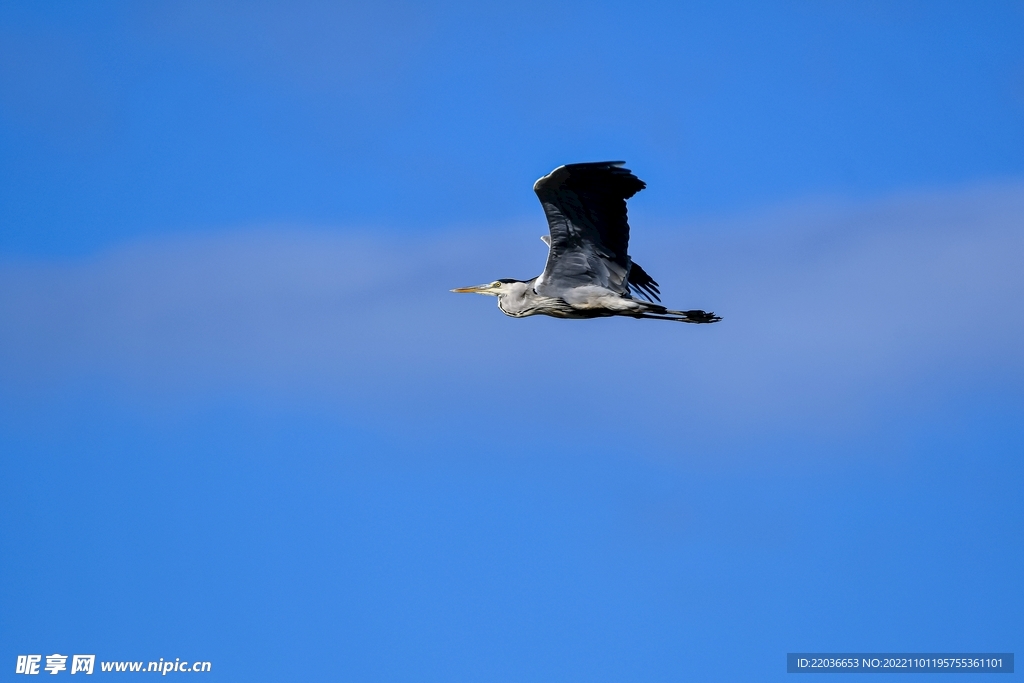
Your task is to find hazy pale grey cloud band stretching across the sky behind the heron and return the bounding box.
[0,185,1024,440]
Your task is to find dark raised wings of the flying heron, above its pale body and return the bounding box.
[534,162,658,298]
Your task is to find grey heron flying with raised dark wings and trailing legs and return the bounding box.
[452,161,722,323]
